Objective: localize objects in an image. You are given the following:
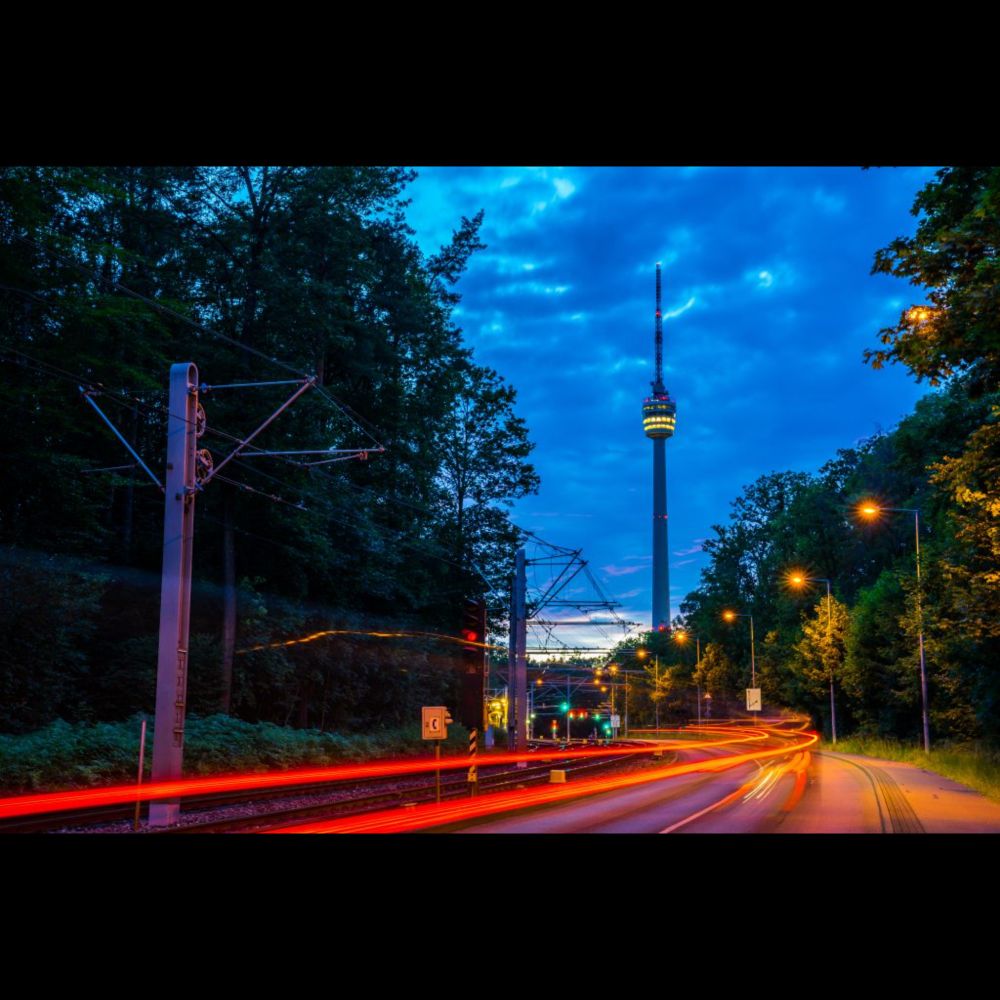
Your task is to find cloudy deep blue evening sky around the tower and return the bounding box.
[408,167,934,648]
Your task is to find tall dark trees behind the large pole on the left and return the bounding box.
[0,166,538,733]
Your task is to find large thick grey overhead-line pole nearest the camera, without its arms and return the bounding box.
[149,362,198,827]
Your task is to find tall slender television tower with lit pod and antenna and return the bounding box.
[642,263,677,629]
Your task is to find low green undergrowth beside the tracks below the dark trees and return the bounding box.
[0,715,468,795]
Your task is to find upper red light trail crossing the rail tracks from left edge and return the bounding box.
[0,730,767,819]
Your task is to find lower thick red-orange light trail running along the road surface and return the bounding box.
[269,733,819,833]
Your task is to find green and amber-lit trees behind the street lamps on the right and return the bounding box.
[640,167,1000,743]
